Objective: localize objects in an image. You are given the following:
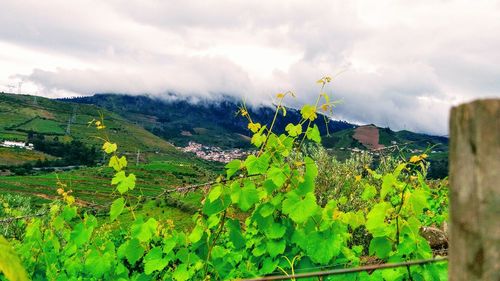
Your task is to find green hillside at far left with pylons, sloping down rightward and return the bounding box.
[0,93,180,154]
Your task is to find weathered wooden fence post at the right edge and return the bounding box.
[449,99,500,281]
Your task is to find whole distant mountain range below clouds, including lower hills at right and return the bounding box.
[62,94,448,178]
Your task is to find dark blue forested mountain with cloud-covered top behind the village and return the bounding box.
[68,94,354,148]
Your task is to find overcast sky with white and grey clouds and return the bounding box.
[0,0,500,135]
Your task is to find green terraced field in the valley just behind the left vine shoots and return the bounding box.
[0,158,221,209]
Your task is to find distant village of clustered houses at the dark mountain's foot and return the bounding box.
[180,141,248,163]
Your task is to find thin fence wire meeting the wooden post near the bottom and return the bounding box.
[242,257,448,281]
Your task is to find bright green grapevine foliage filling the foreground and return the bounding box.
[0,77,446,280]
